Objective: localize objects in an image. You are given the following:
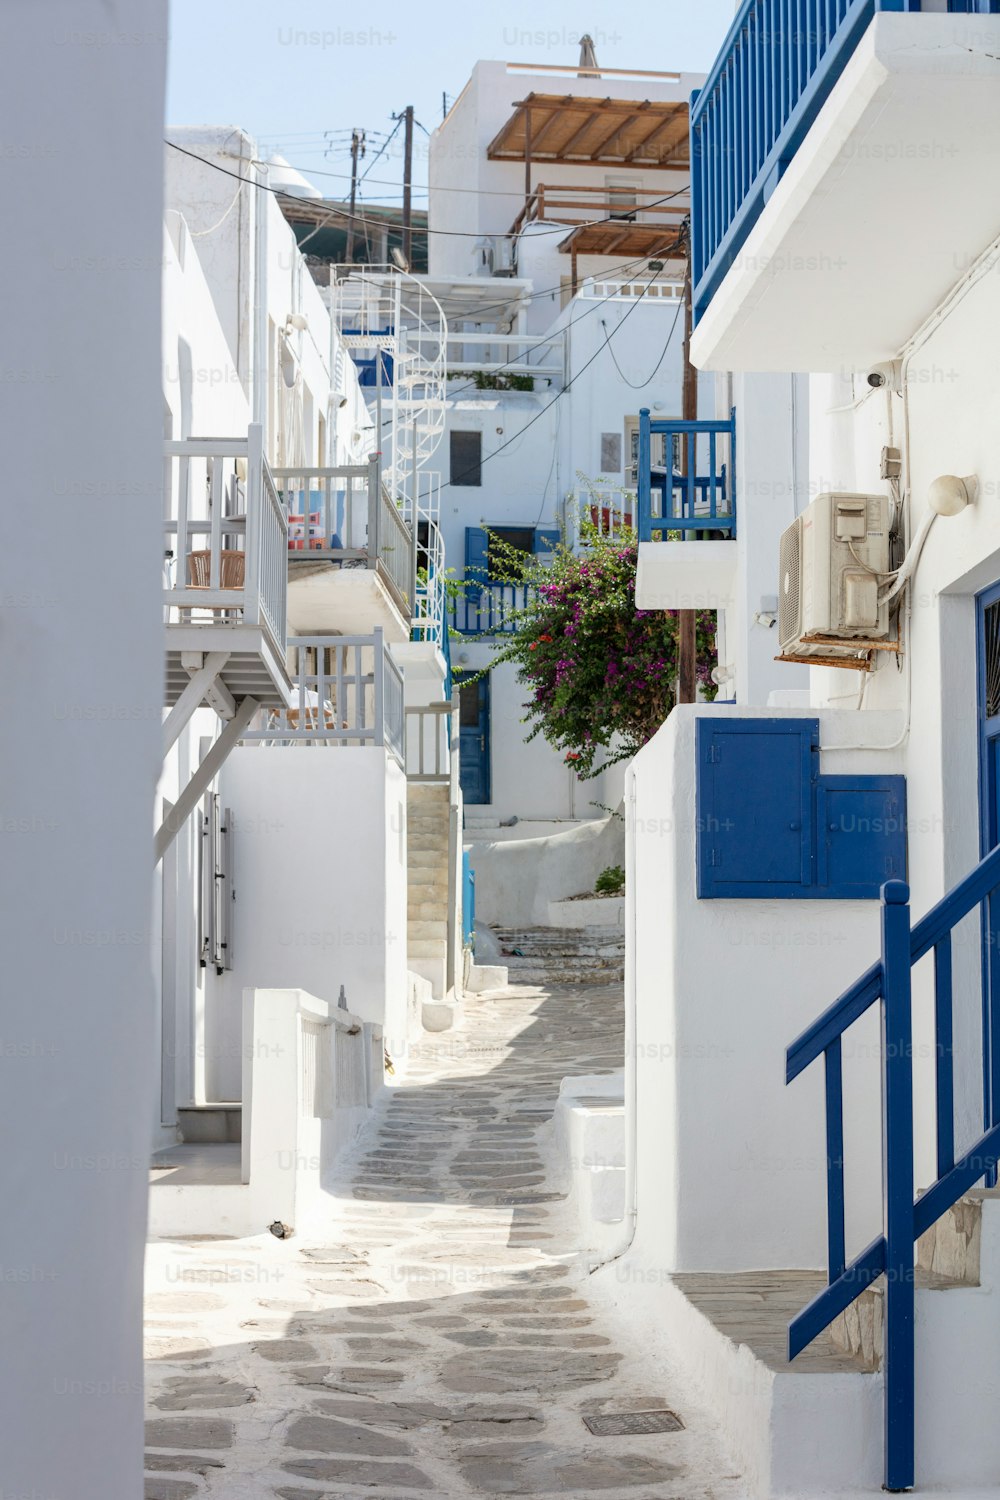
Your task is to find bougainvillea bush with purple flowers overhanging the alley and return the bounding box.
[490,521,717,779]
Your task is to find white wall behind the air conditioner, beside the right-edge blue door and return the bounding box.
[811,269,1000,1185]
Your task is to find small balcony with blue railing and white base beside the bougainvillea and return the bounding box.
[636,407,736,609]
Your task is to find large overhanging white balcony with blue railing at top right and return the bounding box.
[691,0,1000,371]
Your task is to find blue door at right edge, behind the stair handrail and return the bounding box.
[976,584,1000,1146]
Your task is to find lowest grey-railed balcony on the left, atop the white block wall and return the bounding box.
[243,630,403,765]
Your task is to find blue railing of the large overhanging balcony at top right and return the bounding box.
[691,0,1000,323]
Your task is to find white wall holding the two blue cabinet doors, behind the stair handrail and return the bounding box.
[625,705,900,1272]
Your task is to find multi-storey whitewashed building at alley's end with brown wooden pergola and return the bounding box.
[389,62,712,834]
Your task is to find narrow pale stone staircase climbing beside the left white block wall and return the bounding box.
[406,782,450,999]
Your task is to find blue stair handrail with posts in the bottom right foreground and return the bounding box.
[786,849,1000,1490]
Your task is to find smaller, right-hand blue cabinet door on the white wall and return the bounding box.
[816,776,906,900]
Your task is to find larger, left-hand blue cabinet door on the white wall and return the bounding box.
[696,717,819,899]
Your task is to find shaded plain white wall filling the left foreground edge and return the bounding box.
[0,0,166,1500]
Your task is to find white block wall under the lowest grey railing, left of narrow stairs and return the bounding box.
[212,746,406,1100]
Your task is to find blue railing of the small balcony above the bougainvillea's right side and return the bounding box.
[637,407,736,542]
